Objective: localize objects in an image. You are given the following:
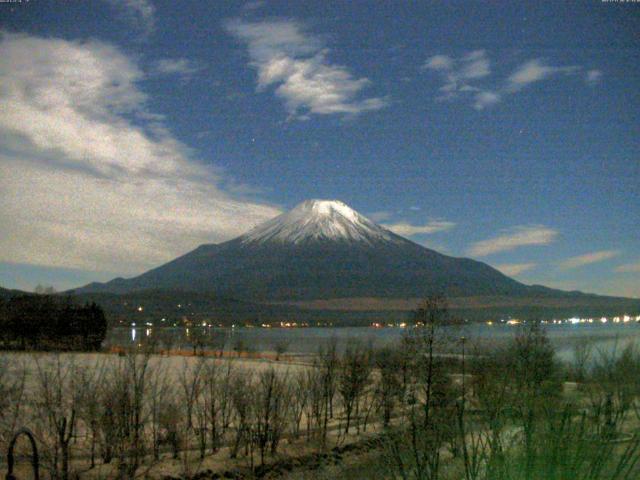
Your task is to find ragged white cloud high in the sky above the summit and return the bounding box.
[226,20,387,119]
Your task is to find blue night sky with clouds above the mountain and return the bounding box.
[0,0,640,296]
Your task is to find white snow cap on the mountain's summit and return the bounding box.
[240,200,400,244]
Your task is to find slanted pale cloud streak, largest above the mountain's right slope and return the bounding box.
[467,225,558,257]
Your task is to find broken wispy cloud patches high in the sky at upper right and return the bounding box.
[422,50,602,110]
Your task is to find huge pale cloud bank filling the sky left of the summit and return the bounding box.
[0,34,279,274]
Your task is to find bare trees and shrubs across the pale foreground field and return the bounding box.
[0,299,640,480]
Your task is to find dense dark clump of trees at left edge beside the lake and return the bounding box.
[0,295,107,351]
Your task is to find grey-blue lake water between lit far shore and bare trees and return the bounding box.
[108,322,640,361]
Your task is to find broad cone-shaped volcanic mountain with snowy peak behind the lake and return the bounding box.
[76,200,542,301]
